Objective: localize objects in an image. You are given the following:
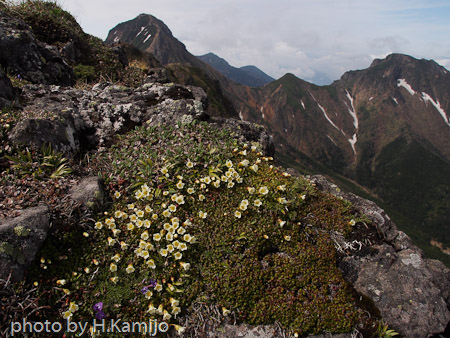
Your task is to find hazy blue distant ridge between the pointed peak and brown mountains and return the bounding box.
[197,53,275,87]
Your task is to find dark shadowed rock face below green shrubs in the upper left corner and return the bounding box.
[0,11,74,85]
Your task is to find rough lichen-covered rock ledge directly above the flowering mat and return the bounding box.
[9,70,274,156]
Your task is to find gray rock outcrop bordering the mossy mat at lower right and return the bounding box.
[311,176,450,338]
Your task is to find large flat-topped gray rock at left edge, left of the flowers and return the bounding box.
[0,206,50,281]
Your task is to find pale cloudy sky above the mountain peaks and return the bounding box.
[57,0,450,84]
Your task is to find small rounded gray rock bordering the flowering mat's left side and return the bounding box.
[69,176,106,210]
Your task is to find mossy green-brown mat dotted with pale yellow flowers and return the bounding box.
[0,122,384,334]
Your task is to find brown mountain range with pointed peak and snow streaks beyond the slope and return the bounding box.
[106,15,450,265]
